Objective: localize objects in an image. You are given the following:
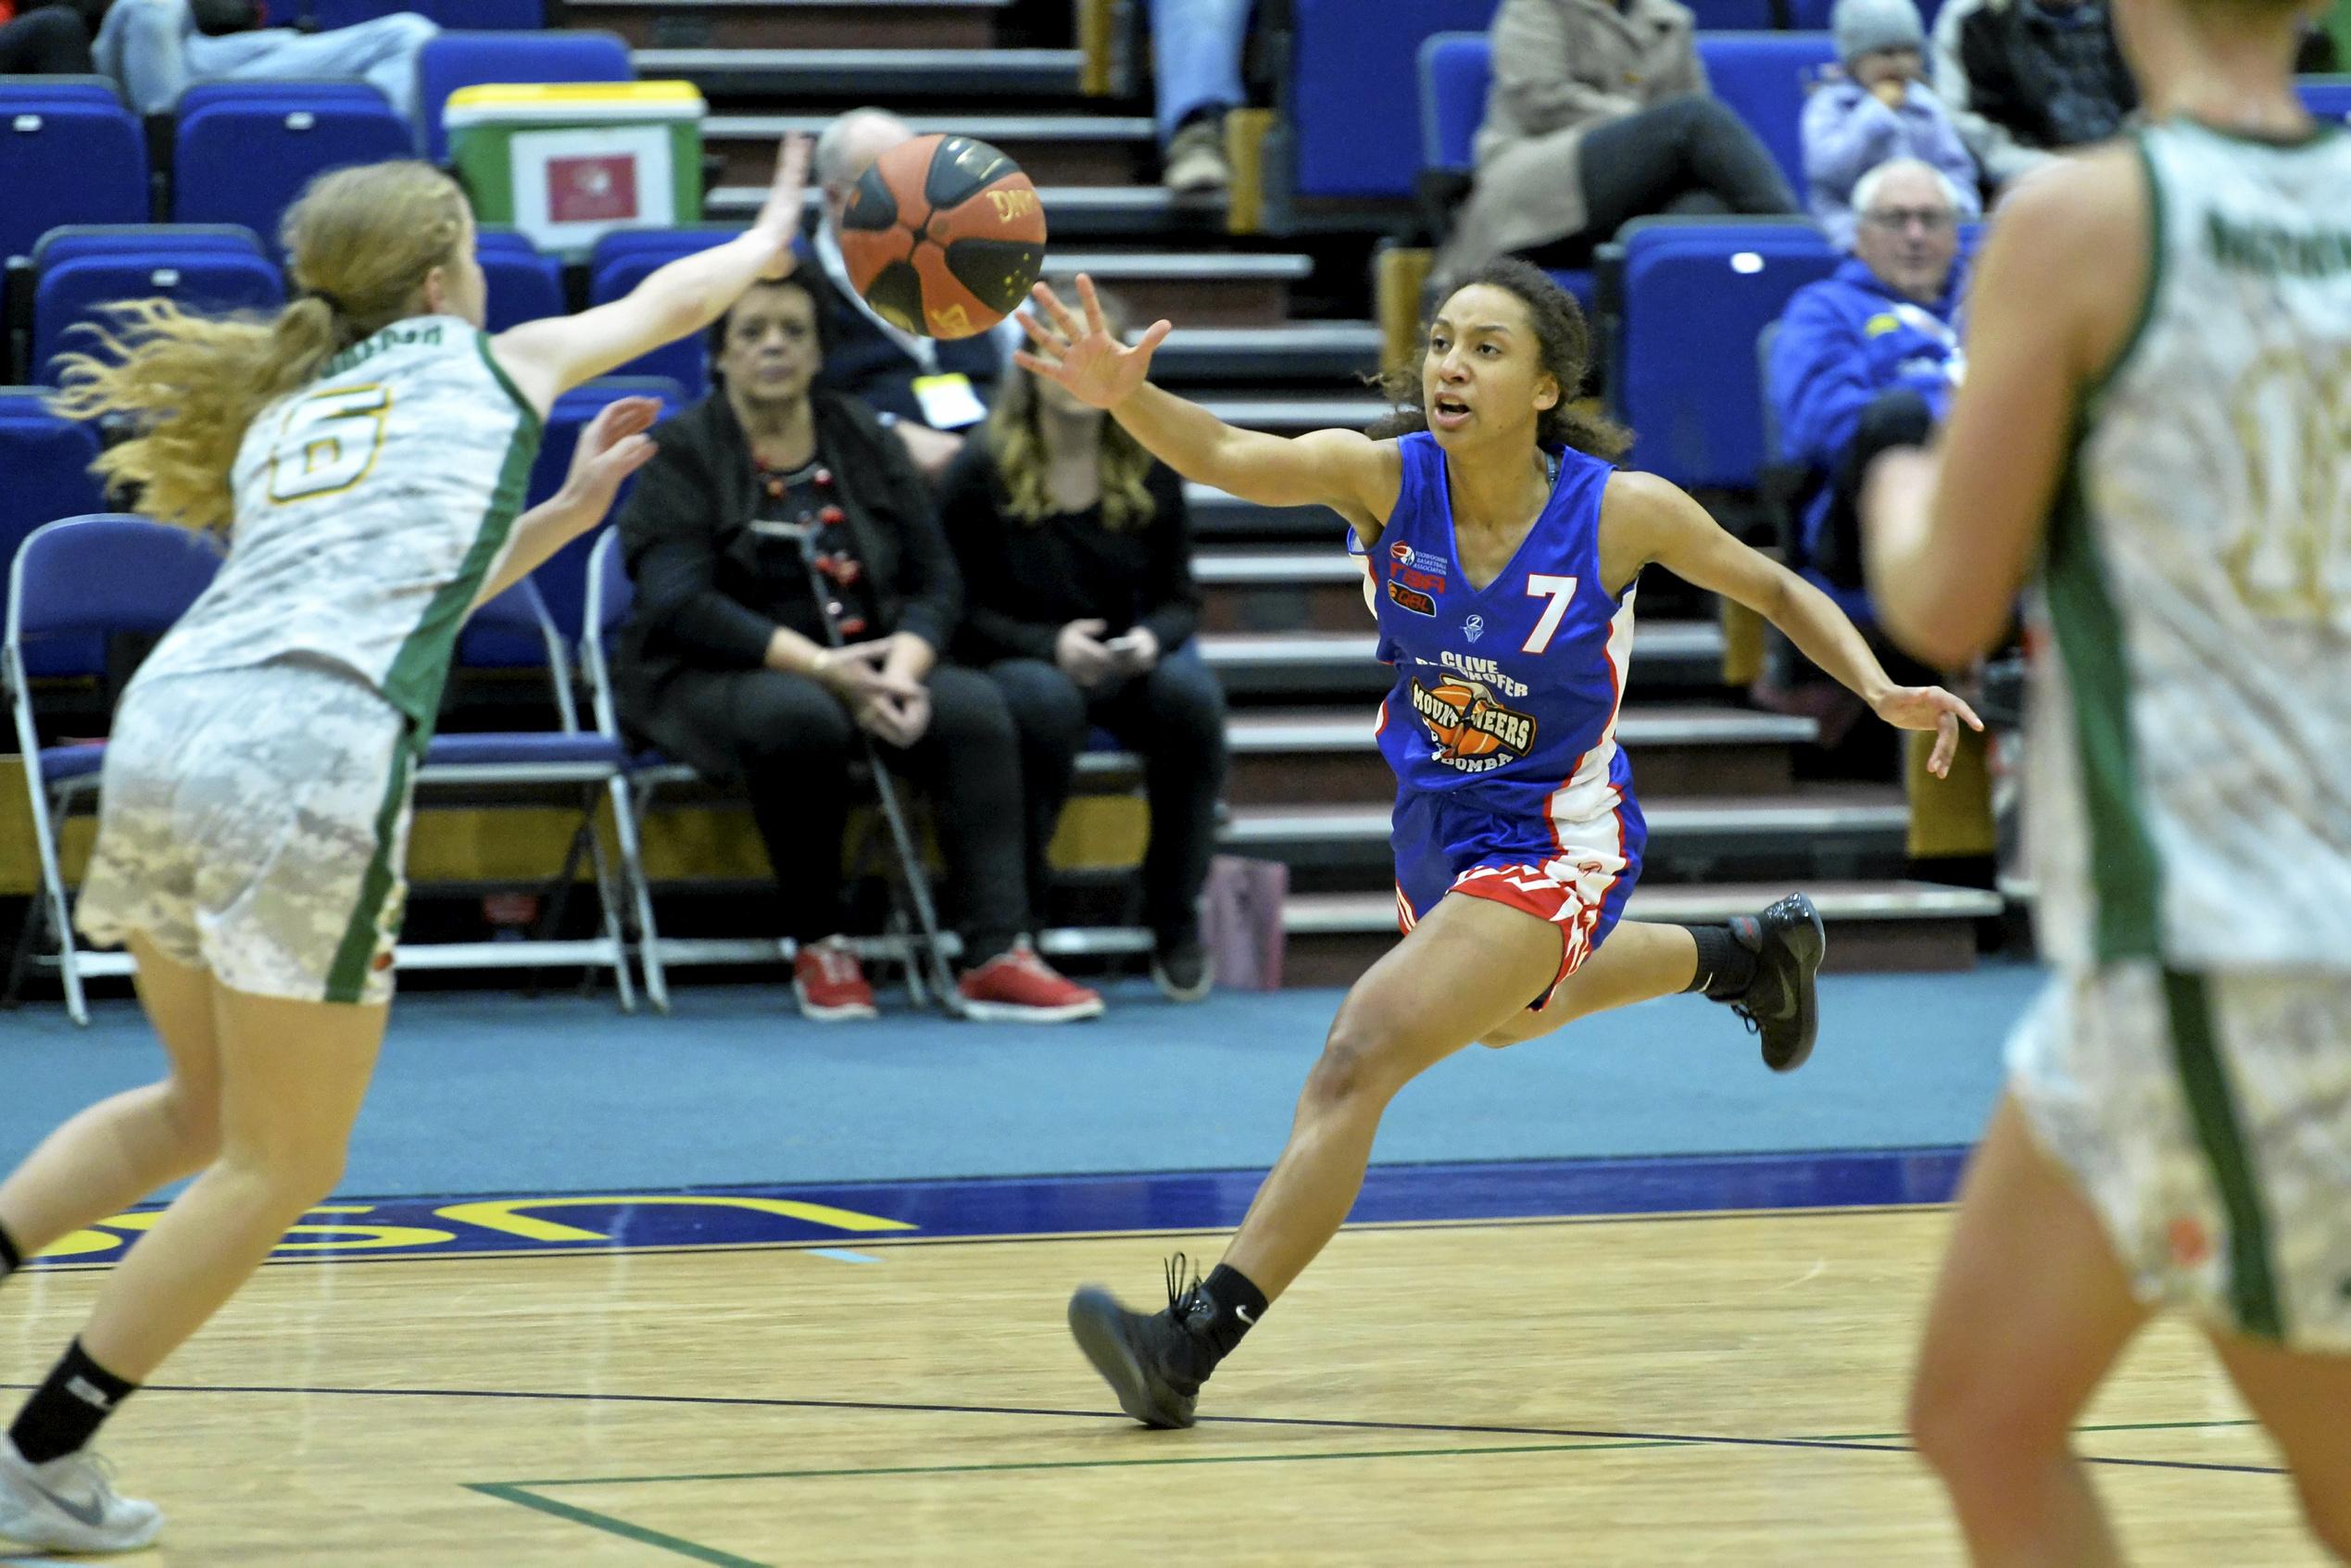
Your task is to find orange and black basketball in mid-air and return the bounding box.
[842,136,1044,339]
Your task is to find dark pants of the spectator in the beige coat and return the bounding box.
[1528,92,1796,268]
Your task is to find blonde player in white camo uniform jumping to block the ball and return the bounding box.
[0,141,807,1551]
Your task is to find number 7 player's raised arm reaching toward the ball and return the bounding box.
[1013,272,1403,546]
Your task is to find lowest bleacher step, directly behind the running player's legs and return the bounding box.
[1281,879,2001,985]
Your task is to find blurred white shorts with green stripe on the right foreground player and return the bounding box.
[2007,961,2351,1351]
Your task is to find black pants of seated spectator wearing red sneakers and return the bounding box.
[663,663,1027,966]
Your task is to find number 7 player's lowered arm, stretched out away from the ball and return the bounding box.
[1601,472,1984,778]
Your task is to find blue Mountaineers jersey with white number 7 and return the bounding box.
[1371,433,1634,825]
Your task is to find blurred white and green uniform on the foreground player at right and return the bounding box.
[2010,122,2351,1349]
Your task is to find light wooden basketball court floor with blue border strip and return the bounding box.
[0,1157,2323,1568]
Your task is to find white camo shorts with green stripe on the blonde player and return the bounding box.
[75,660,414,1001]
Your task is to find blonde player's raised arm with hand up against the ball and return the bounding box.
[491,136,809,414]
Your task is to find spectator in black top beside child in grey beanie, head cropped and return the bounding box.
[1935,0,2140,186]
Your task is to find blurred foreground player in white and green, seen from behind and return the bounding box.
[1867,0,2351,1568]
